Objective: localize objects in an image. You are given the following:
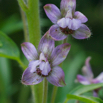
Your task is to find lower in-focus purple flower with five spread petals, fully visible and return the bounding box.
[21,32,71,87]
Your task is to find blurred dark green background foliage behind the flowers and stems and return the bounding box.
[0,0,103,103]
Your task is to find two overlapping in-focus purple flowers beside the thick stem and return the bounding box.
[21,0,91,87]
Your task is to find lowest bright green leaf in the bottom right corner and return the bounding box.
[64,94,103,103]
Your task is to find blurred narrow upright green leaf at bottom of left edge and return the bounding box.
[0,57,12,103]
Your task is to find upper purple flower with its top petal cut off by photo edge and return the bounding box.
[44,0,91,41]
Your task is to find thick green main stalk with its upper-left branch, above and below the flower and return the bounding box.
[18,0,43,103]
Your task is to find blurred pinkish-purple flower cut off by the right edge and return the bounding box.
[77,57,103,96]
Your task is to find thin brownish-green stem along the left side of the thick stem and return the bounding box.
[21,9,29,42]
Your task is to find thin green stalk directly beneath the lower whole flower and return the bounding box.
[42,78,48,103]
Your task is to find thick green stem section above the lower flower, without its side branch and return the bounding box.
[26,0,41,47]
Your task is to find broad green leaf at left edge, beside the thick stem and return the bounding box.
[0,32,20,60]
